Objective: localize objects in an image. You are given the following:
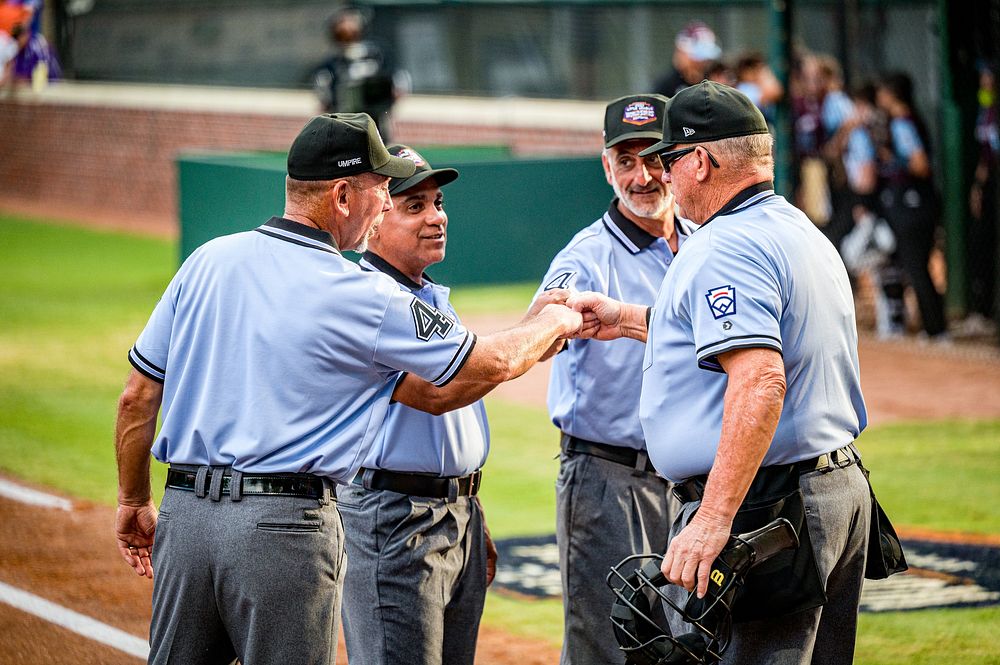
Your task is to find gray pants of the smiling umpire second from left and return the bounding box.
[337,485,486,665]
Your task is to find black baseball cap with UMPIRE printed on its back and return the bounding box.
[288,113,416,180]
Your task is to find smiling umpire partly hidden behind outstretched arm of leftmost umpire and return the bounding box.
[337,145,496,665]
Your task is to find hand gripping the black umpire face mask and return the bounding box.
[660,512,732,598]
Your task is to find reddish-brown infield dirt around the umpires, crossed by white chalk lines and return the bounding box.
[0,326,1000,665]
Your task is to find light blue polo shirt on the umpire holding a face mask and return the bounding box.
[639,183,868,482]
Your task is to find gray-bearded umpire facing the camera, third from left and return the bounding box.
[536,95,687,665]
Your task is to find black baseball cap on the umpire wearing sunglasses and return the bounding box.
[639,81,767,156]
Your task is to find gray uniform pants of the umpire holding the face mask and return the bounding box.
[672,464,871,665]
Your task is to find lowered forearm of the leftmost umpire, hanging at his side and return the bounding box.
[115,370,162,506]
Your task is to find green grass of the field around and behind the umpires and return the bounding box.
[0,215,1000,664]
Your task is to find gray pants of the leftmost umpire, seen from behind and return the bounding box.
[149,480,344,665]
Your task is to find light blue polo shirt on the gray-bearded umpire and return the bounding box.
[536,199,687,450]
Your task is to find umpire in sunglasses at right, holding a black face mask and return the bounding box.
[574,81,871,665]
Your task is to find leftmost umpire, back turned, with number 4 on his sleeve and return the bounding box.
[115,114,580,665]
